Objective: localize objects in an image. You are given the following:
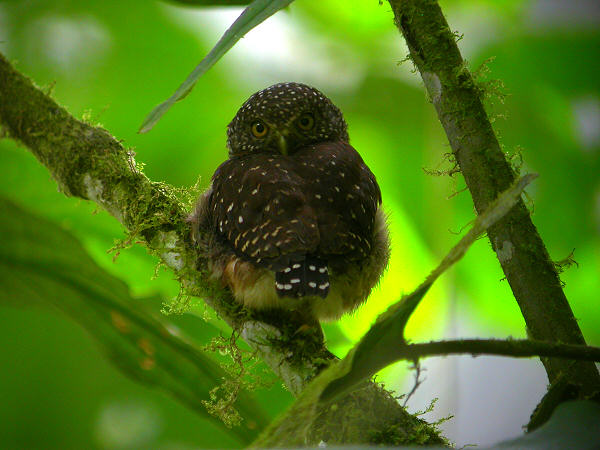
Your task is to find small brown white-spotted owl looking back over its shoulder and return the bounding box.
[191,83,390,320]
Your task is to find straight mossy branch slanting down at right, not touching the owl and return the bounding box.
[389,0,600,397]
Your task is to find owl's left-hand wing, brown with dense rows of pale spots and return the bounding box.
[208,154,319,271]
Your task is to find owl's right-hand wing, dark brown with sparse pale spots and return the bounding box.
[294,141,381,260]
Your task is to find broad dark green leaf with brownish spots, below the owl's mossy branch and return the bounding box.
[0,197,267,443]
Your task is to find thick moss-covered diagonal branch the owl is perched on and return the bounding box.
[0,54,444,444]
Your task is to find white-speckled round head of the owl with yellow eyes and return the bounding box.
[227,83,348,155]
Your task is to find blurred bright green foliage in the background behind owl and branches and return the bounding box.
[0,0,600,448]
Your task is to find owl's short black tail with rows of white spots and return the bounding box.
[275,255,329,298]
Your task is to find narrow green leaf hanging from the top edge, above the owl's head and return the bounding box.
[138,0,294,133]
